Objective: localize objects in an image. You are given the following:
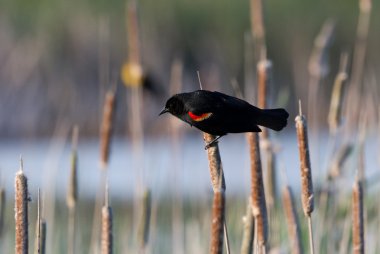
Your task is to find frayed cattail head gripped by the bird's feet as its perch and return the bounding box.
[203,133,226,192]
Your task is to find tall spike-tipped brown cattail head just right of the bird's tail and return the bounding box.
[295,102,314,216]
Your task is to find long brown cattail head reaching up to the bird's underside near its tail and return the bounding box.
[247,133,268,253]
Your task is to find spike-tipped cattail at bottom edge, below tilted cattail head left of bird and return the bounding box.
[101,185,113,254]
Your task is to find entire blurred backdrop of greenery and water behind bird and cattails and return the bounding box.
[0,0,380,253]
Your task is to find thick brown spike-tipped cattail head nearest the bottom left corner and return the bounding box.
[15,159,29,254]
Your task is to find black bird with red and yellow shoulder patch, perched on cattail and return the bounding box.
[160,90,289,149]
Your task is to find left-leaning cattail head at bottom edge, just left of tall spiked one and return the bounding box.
[282,186,303,254]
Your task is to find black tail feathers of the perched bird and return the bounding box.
[257,108,289,131]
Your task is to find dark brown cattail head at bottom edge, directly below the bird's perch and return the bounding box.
[210,189,225,254]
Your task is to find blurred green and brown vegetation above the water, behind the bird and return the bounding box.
[0,0,380,139]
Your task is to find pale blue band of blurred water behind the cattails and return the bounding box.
[0,132,379,198]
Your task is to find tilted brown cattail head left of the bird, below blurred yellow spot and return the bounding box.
[100,90,116,169]
